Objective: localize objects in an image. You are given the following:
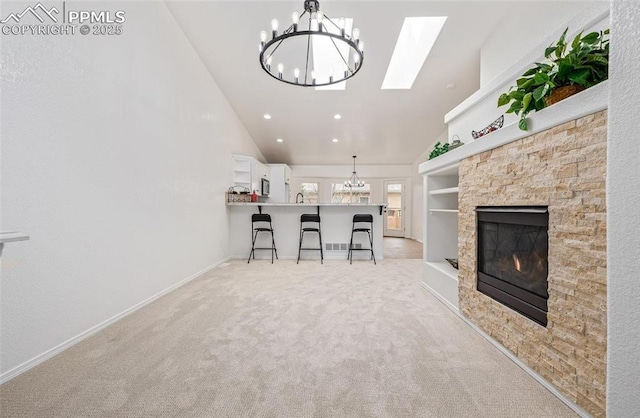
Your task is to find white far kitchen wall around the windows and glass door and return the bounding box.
[291,162,422,239]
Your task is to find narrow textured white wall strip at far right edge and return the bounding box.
[607,0,640,418]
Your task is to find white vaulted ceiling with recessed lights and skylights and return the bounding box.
[167,0,512,165]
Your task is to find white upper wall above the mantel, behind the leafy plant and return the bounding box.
[480,0,608,87]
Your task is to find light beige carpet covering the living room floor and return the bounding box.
[0,260,575,417]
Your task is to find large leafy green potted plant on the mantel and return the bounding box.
[498,28,609,131]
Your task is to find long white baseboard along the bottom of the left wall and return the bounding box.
[0,257,230,384]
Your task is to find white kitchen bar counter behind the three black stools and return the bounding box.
[227,202,387,262]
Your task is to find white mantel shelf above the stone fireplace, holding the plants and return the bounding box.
[418,81,609,174]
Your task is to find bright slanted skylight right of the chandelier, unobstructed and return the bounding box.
[382,16,447,90]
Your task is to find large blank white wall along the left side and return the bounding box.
[0,1,263,378]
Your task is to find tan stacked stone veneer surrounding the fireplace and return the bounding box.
[458,111,607,416]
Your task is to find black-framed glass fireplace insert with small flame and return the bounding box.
[476,206,549,326]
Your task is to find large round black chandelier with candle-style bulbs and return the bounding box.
[259,0,364,87]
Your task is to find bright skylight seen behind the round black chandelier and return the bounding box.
[311,18,353,90]
